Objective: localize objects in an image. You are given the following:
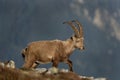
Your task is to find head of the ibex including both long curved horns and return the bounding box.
[63,20,84,50]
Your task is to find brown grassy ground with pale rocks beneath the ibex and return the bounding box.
[0,60,107,80]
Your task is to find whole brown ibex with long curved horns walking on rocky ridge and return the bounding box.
[22,20,84,71]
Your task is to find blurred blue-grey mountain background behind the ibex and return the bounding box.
[0,0,120,80]
